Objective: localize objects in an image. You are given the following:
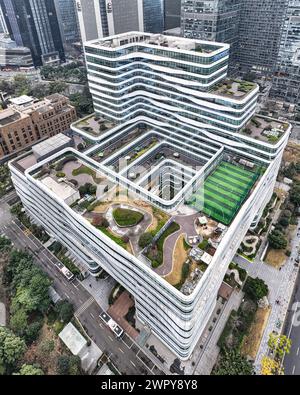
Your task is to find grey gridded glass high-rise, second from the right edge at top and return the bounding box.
[238,0,288,74]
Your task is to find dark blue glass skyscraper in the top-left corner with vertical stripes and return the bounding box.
[0,0,65,66]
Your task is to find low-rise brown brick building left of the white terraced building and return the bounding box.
[0,93,77,159]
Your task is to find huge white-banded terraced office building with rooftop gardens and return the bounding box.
[10,32,290,359]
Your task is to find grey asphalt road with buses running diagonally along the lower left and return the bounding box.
[0,200,163,375]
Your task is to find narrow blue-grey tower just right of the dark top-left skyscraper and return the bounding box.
[54,0,80,45]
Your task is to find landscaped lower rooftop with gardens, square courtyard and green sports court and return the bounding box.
[24,120,265,294]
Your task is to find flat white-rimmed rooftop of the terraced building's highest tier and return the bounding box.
[86,32,229,56]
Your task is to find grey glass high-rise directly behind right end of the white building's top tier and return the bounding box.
[181,0,242,71]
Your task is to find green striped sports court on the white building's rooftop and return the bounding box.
[188,161,260,225]
